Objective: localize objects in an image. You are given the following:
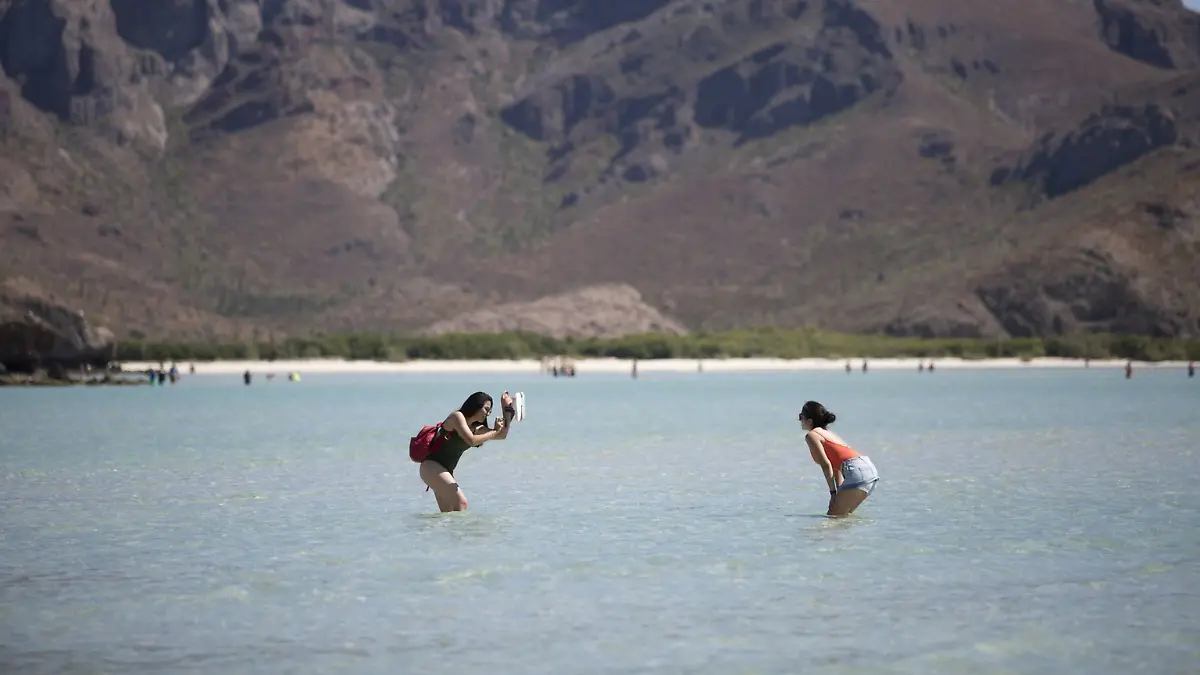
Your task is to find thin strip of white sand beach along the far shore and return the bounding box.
[120,357,1188,376]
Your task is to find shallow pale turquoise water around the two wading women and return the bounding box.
[0,370,1200,675]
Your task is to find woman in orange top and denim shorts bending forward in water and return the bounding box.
[799,401,880,516]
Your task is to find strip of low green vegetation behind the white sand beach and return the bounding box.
[118,328,1200,362]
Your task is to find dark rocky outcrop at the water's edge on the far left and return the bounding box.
[0,281,116,372]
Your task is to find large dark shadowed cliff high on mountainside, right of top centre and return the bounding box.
[500,0,902,208]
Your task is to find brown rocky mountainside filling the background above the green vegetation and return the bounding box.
[0,0,1200,339]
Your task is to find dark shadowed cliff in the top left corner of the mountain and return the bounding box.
[0,0,270,153]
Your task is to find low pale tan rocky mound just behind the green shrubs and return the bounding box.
[425,283,686,339]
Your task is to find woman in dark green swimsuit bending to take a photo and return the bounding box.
[421,392,514,513]
